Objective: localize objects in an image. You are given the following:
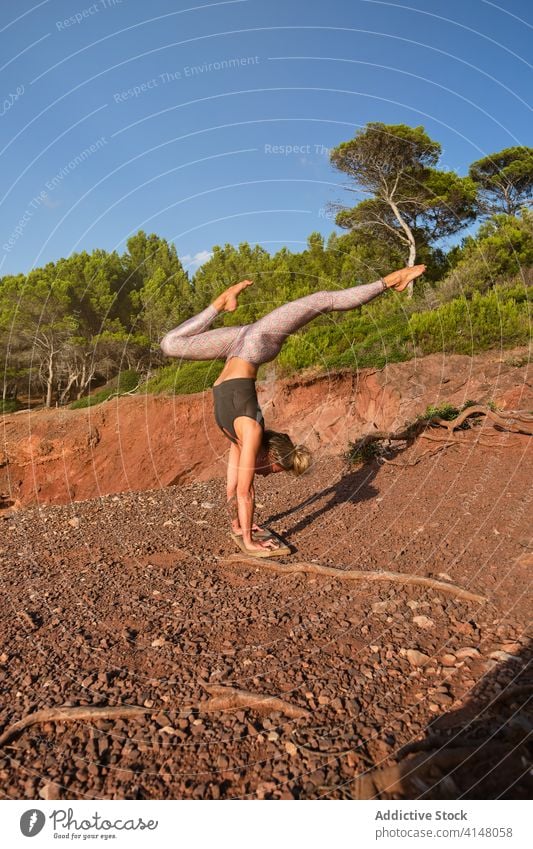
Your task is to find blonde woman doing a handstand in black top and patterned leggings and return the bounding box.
[161,265,426,554]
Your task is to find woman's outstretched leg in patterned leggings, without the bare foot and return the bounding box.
[237,279,388,363]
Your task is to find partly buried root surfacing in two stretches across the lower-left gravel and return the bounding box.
[0,684,311,746]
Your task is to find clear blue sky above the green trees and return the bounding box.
[0,0,533,274]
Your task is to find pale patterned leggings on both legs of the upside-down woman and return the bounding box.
[161,279,387,365]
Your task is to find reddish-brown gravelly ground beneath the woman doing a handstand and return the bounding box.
[0,420,533,799]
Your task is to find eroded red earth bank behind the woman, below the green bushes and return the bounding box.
[0,349,533,506]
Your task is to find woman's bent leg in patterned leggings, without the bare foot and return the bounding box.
[161,304,242,360]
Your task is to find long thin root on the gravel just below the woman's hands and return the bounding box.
[219,554,487,602]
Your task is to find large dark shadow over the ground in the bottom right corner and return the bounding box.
[359,640,533,800]
